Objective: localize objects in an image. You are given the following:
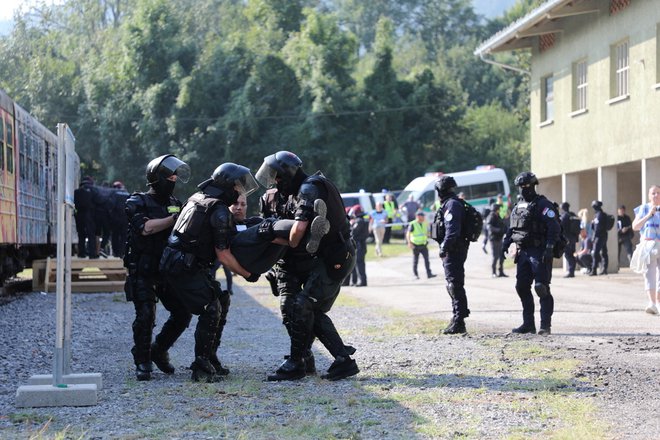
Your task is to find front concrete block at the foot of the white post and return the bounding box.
[16,384,98,408]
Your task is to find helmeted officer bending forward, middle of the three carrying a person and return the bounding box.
[161,162,259,382]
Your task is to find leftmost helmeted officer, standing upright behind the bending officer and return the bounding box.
[124,154,191,380]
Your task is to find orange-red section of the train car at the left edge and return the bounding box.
[0,91,16,244]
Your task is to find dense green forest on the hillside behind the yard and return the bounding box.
[0,0,540,191]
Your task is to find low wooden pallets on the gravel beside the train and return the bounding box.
[32,258,126,293]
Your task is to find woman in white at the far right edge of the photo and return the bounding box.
[631,185,660,315]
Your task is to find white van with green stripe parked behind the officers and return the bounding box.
[397,165,510,212]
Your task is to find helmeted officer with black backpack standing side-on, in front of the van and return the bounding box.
[435,176,470,335]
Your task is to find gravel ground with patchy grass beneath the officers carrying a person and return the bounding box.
[0,284,660,439]
